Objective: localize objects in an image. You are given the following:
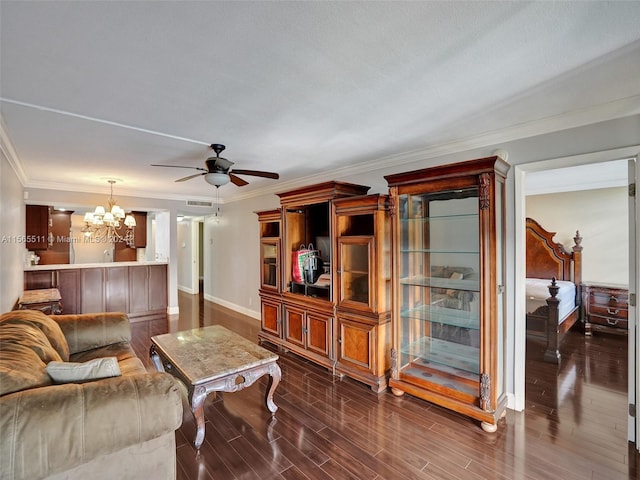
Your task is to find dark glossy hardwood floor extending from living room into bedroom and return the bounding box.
[132,293,640,480]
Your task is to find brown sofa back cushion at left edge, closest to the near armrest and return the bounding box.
[0,343,53,396]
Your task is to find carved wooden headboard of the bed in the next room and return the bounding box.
[526,218,582,285]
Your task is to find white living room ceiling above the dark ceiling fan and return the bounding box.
[0,0,640,201]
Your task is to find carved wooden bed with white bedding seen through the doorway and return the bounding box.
[526,218,582,364]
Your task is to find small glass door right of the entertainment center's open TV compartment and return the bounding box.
[338,236,373,310]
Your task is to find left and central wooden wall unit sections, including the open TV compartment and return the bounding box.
[258,181,369,371]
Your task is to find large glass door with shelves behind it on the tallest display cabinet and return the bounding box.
[398,186,480,401]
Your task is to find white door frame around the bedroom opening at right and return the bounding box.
[509,145,640,426]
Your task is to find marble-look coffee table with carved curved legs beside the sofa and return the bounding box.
[149,325,282,449]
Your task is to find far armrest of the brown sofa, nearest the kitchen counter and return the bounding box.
[50,312,131,353]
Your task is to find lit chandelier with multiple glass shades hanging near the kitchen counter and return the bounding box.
[82,180,136,248]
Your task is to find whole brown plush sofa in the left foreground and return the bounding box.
[0,310,182,480]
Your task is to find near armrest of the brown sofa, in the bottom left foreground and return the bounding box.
[0,372,182,480]
